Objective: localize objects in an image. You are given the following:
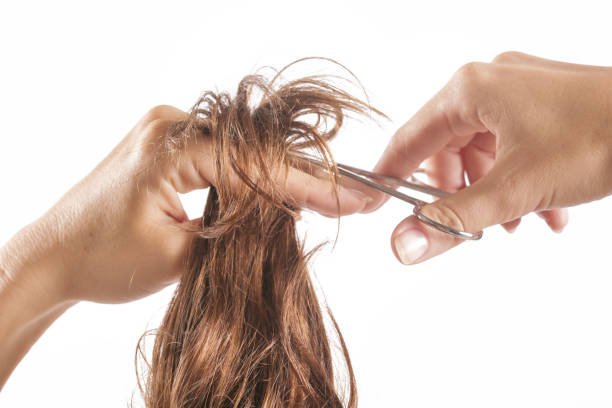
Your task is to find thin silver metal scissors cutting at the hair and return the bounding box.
[291,151,482,241]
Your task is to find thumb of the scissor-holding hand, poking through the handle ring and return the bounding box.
[391,163,529,265]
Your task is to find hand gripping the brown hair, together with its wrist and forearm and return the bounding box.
[0,99,369,388]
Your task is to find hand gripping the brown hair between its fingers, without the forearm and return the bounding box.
[0,106,367,303]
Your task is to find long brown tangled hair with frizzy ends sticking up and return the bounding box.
[141,61,379,408]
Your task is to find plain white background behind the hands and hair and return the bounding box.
[0,1,612,408]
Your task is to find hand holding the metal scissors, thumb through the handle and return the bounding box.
[364,52,612,264]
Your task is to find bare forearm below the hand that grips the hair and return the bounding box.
[0,220,74,389]
